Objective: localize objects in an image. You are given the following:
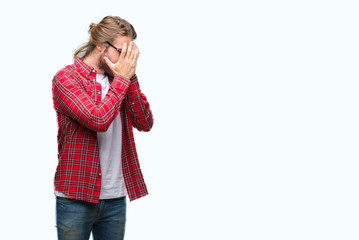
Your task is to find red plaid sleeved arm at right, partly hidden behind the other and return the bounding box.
[126,75,153,132]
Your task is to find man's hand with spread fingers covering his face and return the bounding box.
[104,41,140,79]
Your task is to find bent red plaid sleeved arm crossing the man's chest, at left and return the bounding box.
[52,73,130,132]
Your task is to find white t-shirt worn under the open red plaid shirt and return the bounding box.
[55,73,127,199]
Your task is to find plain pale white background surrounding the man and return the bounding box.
[0,0,359,240]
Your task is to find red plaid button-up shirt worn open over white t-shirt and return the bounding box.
[52,57,153,203]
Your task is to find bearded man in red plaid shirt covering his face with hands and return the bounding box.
[52,16,153,240]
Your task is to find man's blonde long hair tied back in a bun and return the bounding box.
[73,16,137,59]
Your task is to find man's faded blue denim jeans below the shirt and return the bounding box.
[56,196,126,240]
